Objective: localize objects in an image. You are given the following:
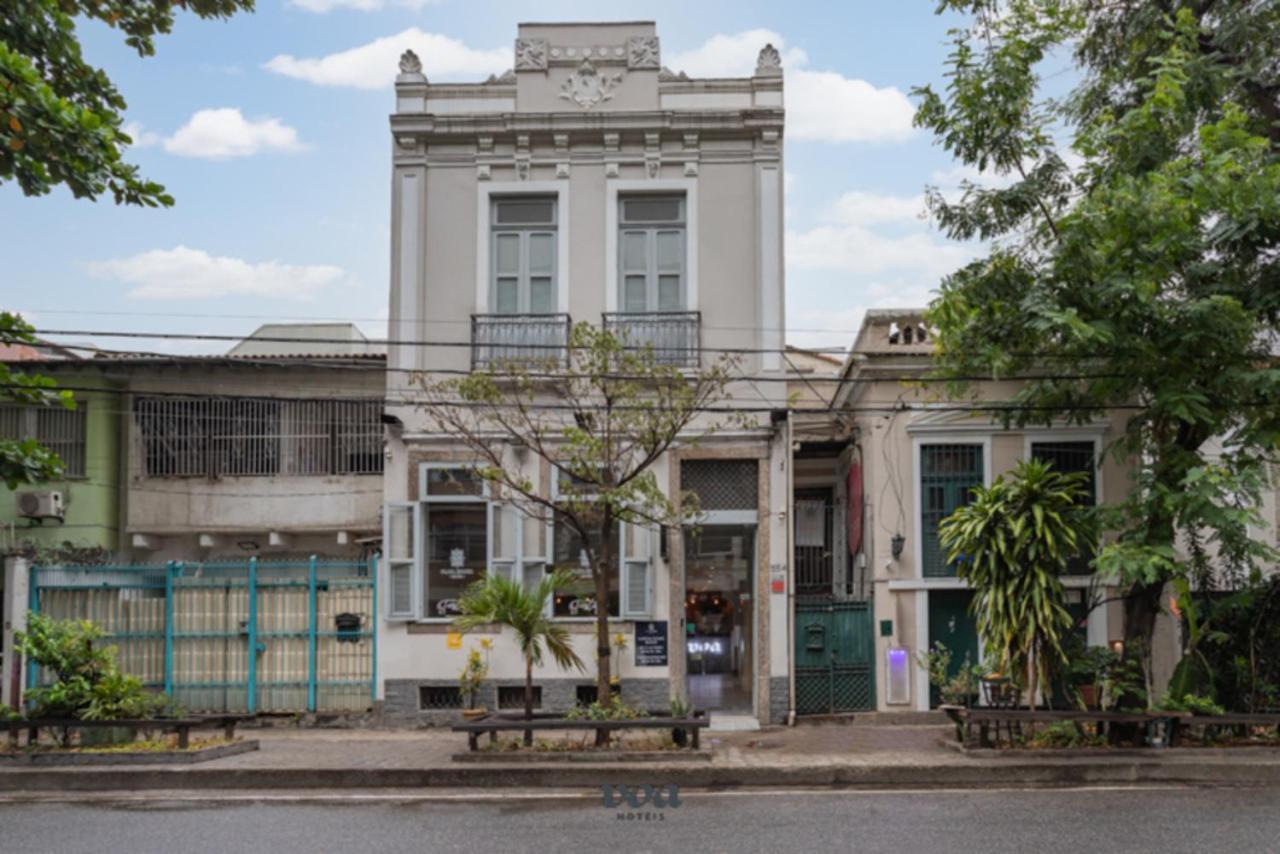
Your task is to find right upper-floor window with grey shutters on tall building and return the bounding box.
[618,195,687,312]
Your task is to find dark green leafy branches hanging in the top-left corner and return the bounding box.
[0,0,253,207]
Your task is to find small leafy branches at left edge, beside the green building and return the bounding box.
[0,311,76,489]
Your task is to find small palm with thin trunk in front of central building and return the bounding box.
[453,570,584,746]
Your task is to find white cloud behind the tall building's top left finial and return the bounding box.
[264,27,512,90]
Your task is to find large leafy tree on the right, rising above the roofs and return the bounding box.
[916,0,1280,649]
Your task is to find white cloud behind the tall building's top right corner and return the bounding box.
[667,29,915,142]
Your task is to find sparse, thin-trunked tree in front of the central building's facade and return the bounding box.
[416,323,742,722]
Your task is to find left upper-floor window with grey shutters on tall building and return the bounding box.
[489,196,557,315]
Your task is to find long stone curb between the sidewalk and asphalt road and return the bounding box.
[0,762,1280,793]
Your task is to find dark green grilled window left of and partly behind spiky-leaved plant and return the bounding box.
[920,444,983,579]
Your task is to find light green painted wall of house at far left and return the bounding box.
[0,370,127,552]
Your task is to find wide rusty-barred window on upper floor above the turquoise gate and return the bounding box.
[133,396,383,478]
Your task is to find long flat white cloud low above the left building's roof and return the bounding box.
[88,246,343,300]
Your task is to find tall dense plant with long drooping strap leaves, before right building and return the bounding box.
[938,460,1089,703]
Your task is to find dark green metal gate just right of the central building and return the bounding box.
[795,597,876,714]
